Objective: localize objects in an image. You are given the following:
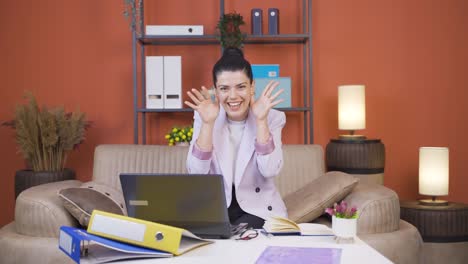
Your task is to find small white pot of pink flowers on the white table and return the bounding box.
[325,201,358,242]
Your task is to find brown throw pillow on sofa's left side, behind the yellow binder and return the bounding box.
[59,182,127,227]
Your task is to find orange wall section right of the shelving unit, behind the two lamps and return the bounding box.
[313,0,468,203]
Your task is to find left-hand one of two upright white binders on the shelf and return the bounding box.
[146,56,164,109]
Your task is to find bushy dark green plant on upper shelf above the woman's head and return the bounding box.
[216,12,245,48]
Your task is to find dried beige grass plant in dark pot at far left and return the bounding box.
[2,93,90,197]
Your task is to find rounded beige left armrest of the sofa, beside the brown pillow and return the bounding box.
[15,180,82,237]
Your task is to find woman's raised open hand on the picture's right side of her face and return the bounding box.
[250,81,284,121]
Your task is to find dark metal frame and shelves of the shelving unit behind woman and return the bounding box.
[131,0,314,144]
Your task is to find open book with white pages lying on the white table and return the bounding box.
[263,216,333,236]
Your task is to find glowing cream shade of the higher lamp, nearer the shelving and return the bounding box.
[338,85,366,130]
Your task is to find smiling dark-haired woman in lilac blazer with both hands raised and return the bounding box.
[185,48,287,228]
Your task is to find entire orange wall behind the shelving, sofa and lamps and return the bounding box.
[0,0,468,226]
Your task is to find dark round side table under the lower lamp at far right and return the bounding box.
[400,201,468,263]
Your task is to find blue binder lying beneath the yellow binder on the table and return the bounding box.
[59,226,173,263]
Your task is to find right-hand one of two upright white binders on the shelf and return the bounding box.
[164,56,182,109]
